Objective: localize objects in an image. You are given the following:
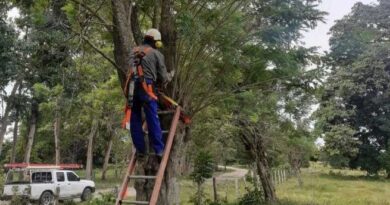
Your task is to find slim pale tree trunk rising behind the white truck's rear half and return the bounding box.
[24,100,39,163]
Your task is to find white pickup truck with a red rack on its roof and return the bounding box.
[3,169,95,205]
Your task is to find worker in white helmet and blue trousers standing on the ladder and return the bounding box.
[128,29,172,160]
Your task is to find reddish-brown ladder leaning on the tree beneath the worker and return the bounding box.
[115,106,181,205]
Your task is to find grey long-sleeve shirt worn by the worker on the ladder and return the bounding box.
[130,44,169,83]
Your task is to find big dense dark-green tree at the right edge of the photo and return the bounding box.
[317,1,390,174]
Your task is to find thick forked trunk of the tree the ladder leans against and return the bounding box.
[111,0,186,205]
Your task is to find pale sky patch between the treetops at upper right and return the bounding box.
[302,0,377,52]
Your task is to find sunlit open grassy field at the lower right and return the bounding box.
[277,164,390,205]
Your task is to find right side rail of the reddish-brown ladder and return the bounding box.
[149,106,181,205]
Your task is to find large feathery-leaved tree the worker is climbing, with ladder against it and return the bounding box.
[64,0,323,204]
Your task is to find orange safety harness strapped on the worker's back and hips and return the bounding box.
[122,47,158,128]
